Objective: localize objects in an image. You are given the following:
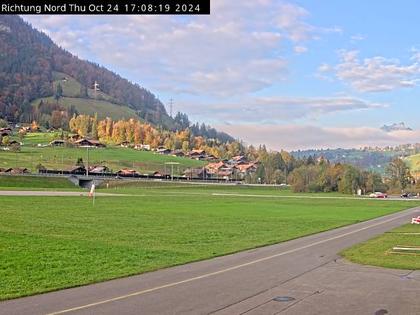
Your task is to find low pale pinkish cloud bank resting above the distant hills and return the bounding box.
[217,124,420,150]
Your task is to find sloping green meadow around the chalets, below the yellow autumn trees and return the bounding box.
[0,133,206,174]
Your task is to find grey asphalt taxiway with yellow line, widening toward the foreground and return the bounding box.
[0,208,420,315]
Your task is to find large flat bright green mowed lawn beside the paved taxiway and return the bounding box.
[0,187,420,299]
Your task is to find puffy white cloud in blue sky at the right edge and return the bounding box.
[318,50,420,92]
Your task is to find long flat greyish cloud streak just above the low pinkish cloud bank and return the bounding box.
[180,96,386,125]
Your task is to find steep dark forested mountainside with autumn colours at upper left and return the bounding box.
[0,15,173,127]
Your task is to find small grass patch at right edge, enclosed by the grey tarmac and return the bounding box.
[342,224,420,270]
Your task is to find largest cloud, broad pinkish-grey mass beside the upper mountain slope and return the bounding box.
[25,0,340,97]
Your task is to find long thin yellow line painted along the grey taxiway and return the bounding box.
[47,208,418,315]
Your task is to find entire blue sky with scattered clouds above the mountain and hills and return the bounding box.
[23,0,420,150]
